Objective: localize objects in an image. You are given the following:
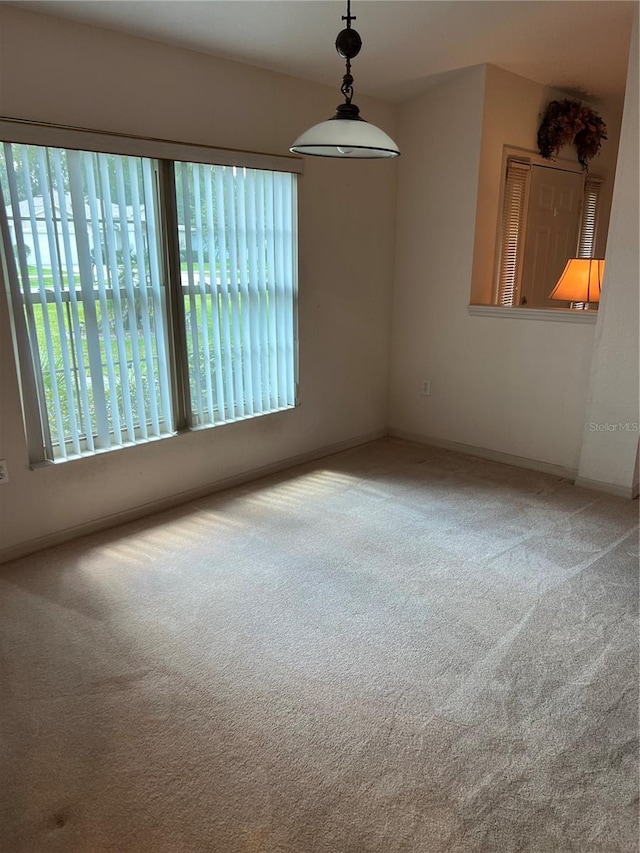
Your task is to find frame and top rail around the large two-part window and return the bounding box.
[0,117,303,467]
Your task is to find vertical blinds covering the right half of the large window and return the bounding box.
[175,163,297,425]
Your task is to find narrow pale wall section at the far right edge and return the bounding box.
[578,10,640,496]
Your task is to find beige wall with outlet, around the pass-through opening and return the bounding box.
[390,66,615,473]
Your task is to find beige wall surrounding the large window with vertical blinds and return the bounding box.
[0,4,396,554]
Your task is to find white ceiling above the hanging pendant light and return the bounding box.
[9,0,636,101]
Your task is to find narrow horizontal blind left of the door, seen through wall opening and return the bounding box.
[496,160,531,305]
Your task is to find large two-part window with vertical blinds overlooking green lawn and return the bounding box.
[0,125,297,462]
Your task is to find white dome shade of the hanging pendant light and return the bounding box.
[289,118,400,160]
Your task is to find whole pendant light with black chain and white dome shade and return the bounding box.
[289,0,400,160]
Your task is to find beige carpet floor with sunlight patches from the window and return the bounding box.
[0,439,638,853]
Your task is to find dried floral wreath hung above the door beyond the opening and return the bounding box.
[538,100,607,169]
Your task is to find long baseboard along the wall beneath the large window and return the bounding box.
[0,428,388,563]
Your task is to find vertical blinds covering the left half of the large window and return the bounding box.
[2,143,171,458]
